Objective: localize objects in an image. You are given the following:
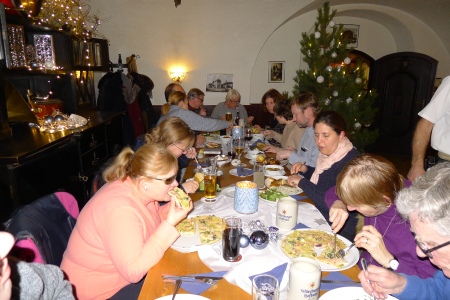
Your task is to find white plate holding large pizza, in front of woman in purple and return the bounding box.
[278,229,359,272]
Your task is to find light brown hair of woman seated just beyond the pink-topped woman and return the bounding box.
[145,117,195,148]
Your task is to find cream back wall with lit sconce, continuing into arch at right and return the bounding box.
[90,0,450,104]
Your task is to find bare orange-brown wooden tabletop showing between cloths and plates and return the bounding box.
[139,155,360,300]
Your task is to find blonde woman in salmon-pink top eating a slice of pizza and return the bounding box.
[61,143,192,299]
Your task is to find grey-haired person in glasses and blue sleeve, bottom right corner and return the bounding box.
[358,162,450,300]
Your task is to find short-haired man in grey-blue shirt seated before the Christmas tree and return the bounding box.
[277,92,320,169]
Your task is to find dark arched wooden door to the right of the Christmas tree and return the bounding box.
[368,52,437,156]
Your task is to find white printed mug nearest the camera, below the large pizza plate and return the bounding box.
[287,257,321,300]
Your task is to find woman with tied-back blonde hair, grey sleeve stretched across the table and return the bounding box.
[157,91,233,132]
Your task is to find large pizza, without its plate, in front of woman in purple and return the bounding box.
[281,230,346,268]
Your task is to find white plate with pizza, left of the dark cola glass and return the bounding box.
[170,215,222,252]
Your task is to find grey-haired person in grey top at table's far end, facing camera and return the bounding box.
[211,89,253,124]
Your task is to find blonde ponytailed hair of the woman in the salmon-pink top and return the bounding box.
[102,143,178,182]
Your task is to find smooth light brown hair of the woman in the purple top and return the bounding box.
[336,153,405,207]
